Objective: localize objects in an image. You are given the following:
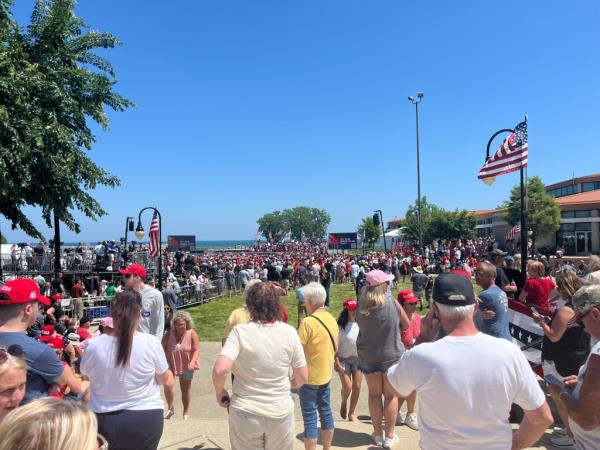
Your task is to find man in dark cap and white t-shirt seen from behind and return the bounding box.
[388,273,553,450]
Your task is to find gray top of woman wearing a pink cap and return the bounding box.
[356,293,405,364]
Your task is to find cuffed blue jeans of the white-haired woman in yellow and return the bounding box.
[298,383,335,439]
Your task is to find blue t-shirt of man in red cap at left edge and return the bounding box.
[0,331,64,405]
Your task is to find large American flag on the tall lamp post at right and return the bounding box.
[478,121,527,184]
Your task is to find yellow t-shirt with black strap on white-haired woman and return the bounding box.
[298,310,338,385]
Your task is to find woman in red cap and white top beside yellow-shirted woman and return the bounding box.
[335,298,363,422]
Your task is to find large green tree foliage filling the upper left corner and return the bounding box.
[0,0,132,238]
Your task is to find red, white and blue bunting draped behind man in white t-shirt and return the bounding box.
[508,299,550,376]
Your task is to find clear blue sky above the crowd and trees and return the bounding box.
[0,0,600,241]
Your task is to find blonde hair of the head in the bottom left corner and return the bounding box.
[0,397,98,450]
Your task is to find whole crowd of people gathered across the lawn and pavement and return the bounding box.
[0,237,600,450]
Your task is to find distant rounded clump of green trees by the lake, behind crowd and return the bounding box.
[256,206,331,241]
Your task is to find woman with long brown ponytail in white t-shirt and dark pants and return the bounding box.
[81,290,174,450]
